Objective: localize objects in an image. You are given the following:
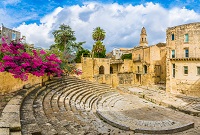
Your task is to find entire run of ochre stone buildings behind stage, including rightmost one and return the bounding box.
[79,22,200,96]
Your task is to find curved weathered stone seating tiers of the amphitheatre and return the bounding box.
[0,76,194,135]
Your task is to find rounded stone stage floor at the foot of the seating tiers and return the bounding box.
[97,95,194,134]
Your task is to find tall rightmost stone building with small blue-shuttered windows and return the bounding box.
[166,22,200,96]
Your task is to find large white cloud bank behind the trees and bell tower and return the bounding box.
[17,2,200,51]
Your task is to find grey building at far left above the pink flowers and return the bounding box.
[0,25,21,42]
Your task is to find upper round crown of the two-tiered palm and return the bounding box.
[92,27,106,41]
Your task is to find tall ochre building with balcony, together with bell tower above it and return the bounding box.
[132,27,166,86]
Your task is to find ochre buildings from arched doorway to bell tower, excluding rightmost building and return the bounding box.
[81,27,166,86]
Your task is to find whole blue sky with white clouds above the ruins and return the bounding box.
[0,0,200,52]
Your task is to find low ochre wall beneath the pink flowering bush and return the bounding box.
[0,72,48,94]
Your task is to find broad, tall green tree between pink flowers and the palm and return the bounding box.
[49,24,85,72]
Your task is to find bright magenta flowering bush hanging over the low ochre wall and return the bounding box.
[0,39,62,81]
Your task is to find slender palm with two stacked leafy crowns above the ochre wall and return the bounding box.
[92,27,106,58]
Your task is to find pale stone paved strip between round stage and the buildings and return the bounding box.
[118,86,200,117]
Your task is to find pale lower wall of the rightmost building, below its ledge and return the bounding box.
[167,61,200,96]
